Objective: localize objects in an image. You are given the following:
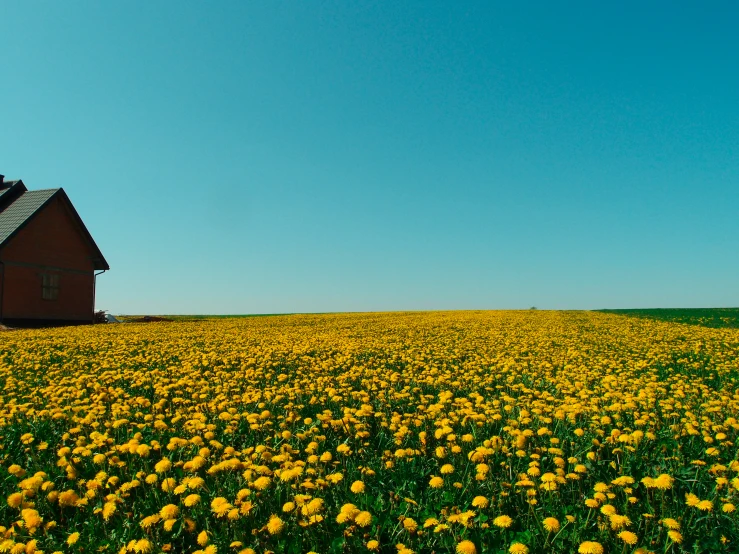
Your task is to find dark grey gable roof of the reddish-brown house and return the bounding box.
[0,187,110,270]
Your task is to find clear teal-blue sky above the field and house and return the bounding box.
[0,0,739,314]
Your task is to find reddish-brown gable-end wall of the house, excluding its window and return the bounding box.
[0,197,95,322]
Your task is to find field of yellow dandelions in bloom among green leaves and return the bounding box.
[0,311,739,554]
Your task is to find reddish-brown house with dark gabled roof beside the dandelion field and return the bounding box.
[0,175,110,326]
